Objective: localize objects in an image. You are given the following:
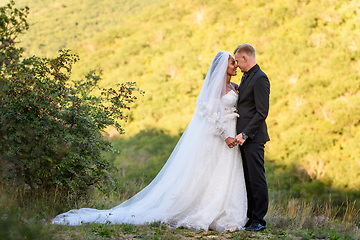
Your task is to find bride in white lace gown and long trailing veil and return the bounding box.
[52,51,247,231]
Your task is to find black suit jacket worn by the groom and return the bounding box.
[236,64,270,142]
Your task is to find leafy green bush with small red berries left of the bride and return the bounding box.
[0,1,143,199]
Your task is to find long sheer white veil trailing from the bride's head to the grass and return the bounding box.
[52,51,242,231]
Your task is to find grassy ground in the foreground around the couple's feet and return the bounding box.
[0,182,360,239]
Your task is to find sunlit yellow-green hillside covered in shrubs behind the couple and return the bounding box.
[7,0,360,202]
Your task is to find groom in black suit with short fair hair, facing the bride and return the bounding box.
[234,44,270,231]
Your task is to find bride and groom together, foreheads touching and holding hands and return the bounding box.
[52,44,270,231]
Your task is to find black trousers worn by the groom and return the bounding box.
[240,141,269,226]
